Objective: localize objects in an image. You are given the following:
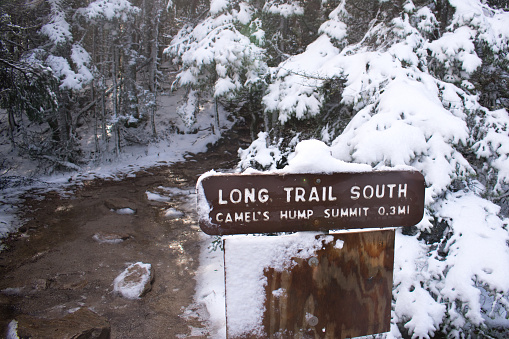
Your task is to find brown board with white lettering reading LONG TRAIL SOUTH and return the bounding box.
[197,171,425,235]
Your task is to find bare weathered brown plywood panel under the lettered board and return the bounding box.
[225,230,394,339]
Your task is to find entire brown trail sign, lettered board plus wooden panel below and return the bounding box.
[198,171,425,338]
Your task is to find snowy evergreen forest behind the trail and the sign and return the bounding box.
[0,0,509,338]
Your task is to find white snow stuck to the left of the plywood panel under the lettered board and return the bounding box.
[225,232,334,337]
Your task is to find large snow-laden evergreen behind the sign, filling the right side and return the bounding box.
[241,0,509,338]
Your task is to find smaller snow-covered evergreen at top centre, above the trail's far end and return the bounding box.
[166,0,266,131]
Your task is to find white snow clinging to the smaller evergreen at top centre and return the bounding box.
[169,7,267,115]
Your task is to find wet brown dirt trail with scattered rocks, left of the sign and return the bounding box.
[0,129,247,338]
